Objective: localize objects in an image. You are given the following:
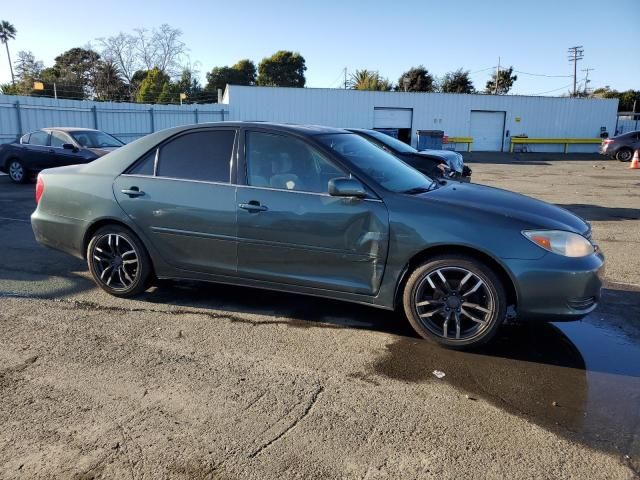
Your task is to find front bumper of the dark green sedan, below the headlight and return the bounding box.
[508,252,604,322]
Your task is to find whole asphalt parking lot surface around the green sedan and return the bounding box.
[0,154,640,479]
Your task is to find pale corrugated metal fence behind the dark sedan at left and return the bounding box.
[0,95,229,143]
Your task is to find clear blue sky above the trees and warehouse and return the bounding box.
[0,0,640,95]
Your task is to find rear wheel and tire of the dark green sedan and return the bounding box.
[87,225,152,297]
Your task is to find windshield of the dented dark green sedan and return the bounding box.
[316,133,435,192]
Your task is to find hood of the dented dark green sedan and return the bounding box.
[422,182,591,236]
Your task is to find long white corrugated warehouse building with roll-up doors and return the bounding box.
[222,85,618,152]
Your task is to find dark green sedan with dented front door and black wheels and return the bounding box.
[31,122,603,348]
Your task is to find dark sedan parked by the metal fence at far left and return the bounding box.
[0,128,124,183]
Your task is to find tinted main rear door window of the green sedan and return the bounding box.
[156,130,236,183]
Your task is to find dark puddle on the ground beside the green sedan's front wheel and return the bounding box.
[371,292,640,472]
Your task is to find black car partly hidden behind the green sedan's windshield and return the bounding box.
[348,128,471,182]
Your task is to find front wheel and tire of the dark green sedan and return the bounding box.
[402,255,507,350]
